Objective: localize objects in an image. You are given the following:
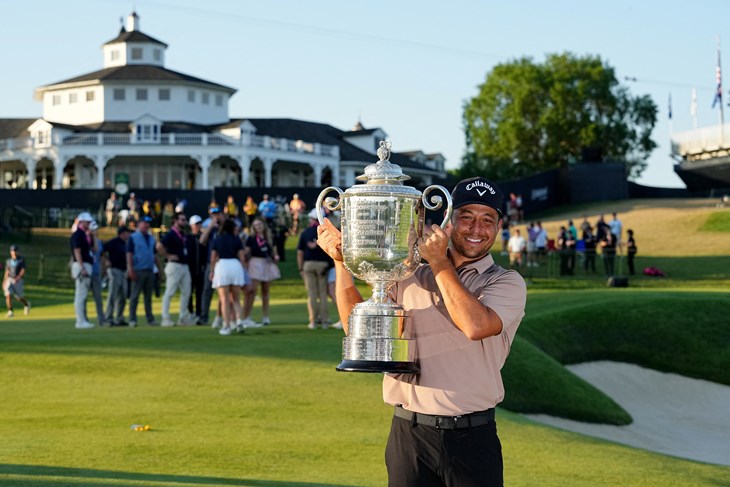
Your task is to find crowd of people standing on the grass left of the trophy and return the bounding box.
[64,193,341,335]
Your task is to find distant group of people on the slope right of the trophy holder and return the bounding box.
[502,212,638,277]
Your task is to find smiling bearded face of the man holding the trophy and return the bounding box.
[451,204,502,260]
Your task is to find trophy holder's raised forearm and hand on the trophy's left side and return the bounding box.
[317,219,363,333]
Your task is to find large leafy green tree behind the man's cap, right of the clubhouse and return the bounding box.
[459,53,657,180]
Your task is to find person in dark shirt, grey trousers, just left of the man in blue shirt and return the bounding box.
[103,227,130,326]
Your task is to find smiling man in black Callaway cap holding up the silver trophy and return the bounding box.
[318,177,526,487]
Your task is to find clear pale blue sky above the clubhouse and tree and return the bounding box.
[0,0,730,187]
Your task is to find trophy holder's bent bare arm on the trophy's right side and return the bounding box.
[418,225,502,340]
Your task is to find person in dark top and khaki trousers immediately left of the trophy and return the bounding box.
[297,210,334,330]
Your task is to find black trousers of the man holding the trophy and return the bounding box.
[385,417,503,487]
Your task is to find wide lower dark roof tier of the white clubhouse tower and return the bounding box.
[38,64,236,93]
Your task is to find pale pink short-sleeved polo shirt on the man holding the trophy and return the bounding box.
[383,255,527,416]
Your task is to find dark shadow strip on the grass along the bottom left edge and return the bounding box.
[0,463,351,487]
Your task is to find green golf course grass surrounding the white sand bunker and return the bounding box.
[0,202,730,487]
